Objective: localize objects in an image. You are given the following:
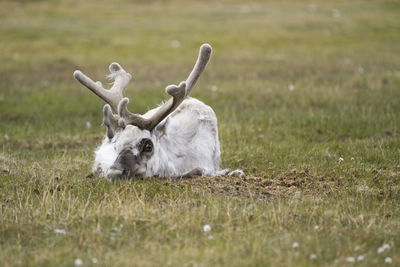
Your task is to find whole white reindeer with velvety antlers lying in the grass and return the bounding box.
[74,44,221,181]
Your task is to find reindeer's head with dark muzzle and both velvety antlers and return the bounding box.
[74,44,212,180]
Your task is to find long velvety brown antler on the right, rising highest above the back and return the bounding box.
[118,44,212,131]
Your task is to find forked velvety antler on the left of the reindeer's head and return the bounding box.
[74,62,132,113]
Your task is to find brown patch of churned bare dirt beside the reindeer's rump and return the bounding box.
[166,169,340,199]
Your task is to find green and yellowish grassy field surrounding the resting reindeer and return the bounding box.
[0,0,400,266]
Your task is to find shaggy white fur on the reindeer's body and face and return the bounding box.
[93,98,221,177]
